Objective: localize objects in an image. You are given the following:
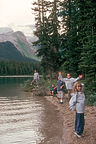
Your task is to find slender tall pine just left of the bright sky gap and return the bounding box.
[48,0,63,72]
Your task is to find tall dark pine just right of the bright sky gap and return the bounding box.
[60,0,80,73]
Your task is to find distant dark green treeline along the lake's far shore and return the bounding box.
[0,60,41,75]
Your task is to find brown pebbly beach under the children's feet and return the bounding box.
[46,96,96,144]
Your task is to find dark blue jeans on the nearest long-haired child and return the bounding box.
[75,113,85,135]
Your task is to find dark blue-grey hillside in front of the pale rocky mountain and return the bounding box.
[0,41,35,61]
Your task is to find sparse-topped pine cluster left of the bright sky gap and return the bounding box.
[34,0,62,79]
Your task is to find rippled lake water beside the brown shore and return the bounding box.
[0,78,63,144]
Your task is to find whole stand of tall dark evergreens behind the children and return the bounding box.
[32,0,96,95]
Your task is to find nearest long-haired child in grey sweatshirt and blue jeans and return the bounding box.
[69,82,85,138]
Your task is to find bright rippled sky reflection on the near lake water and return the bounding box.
[0,96,43,144]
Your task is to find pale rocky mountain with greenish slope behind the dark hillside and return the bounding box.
[0,28,39,60]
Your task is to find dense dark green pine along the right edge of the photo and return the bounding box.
[77,0,96,90]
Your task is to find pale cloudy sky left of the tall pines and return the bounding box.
[0,0,35,36]
